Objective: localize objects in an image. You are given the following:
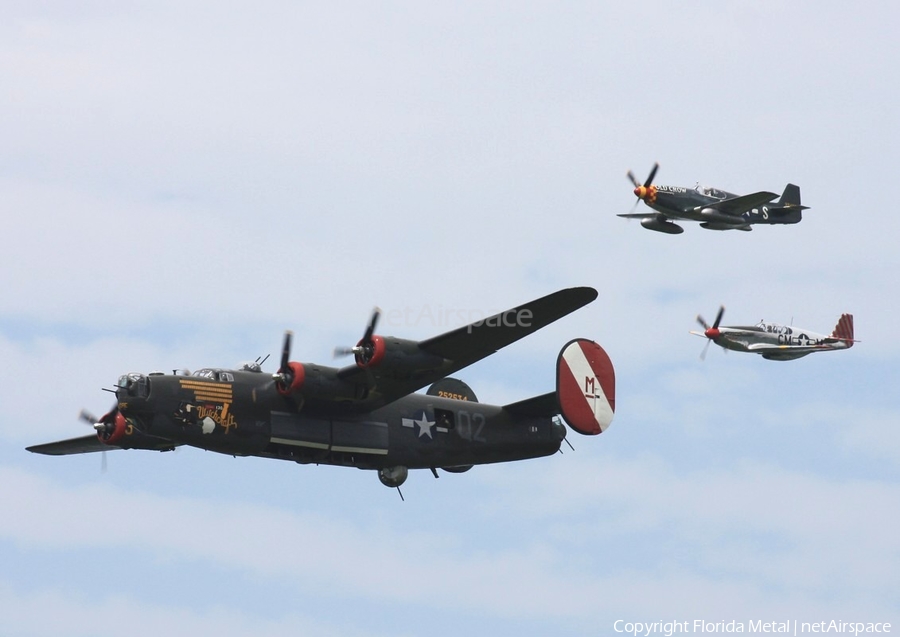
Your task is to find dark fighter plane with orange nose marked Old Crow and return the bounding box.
[617,164,809,234]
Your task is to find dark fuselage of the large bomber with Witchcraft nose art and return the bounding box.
[116,368,565,469]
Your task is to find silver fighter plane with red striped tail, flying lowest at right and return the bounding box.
[691,307,856,361]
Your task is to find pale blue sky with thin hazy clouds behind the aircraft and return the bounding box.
[0,0,900,637]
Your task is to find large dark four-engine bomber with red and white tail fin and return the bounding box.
[28,287,615,496]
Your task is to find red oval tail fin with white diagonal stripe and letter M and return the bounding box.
[556,338,616,435]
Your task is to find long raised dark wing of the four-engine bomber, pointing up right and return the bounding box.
[338,287,597,409]
